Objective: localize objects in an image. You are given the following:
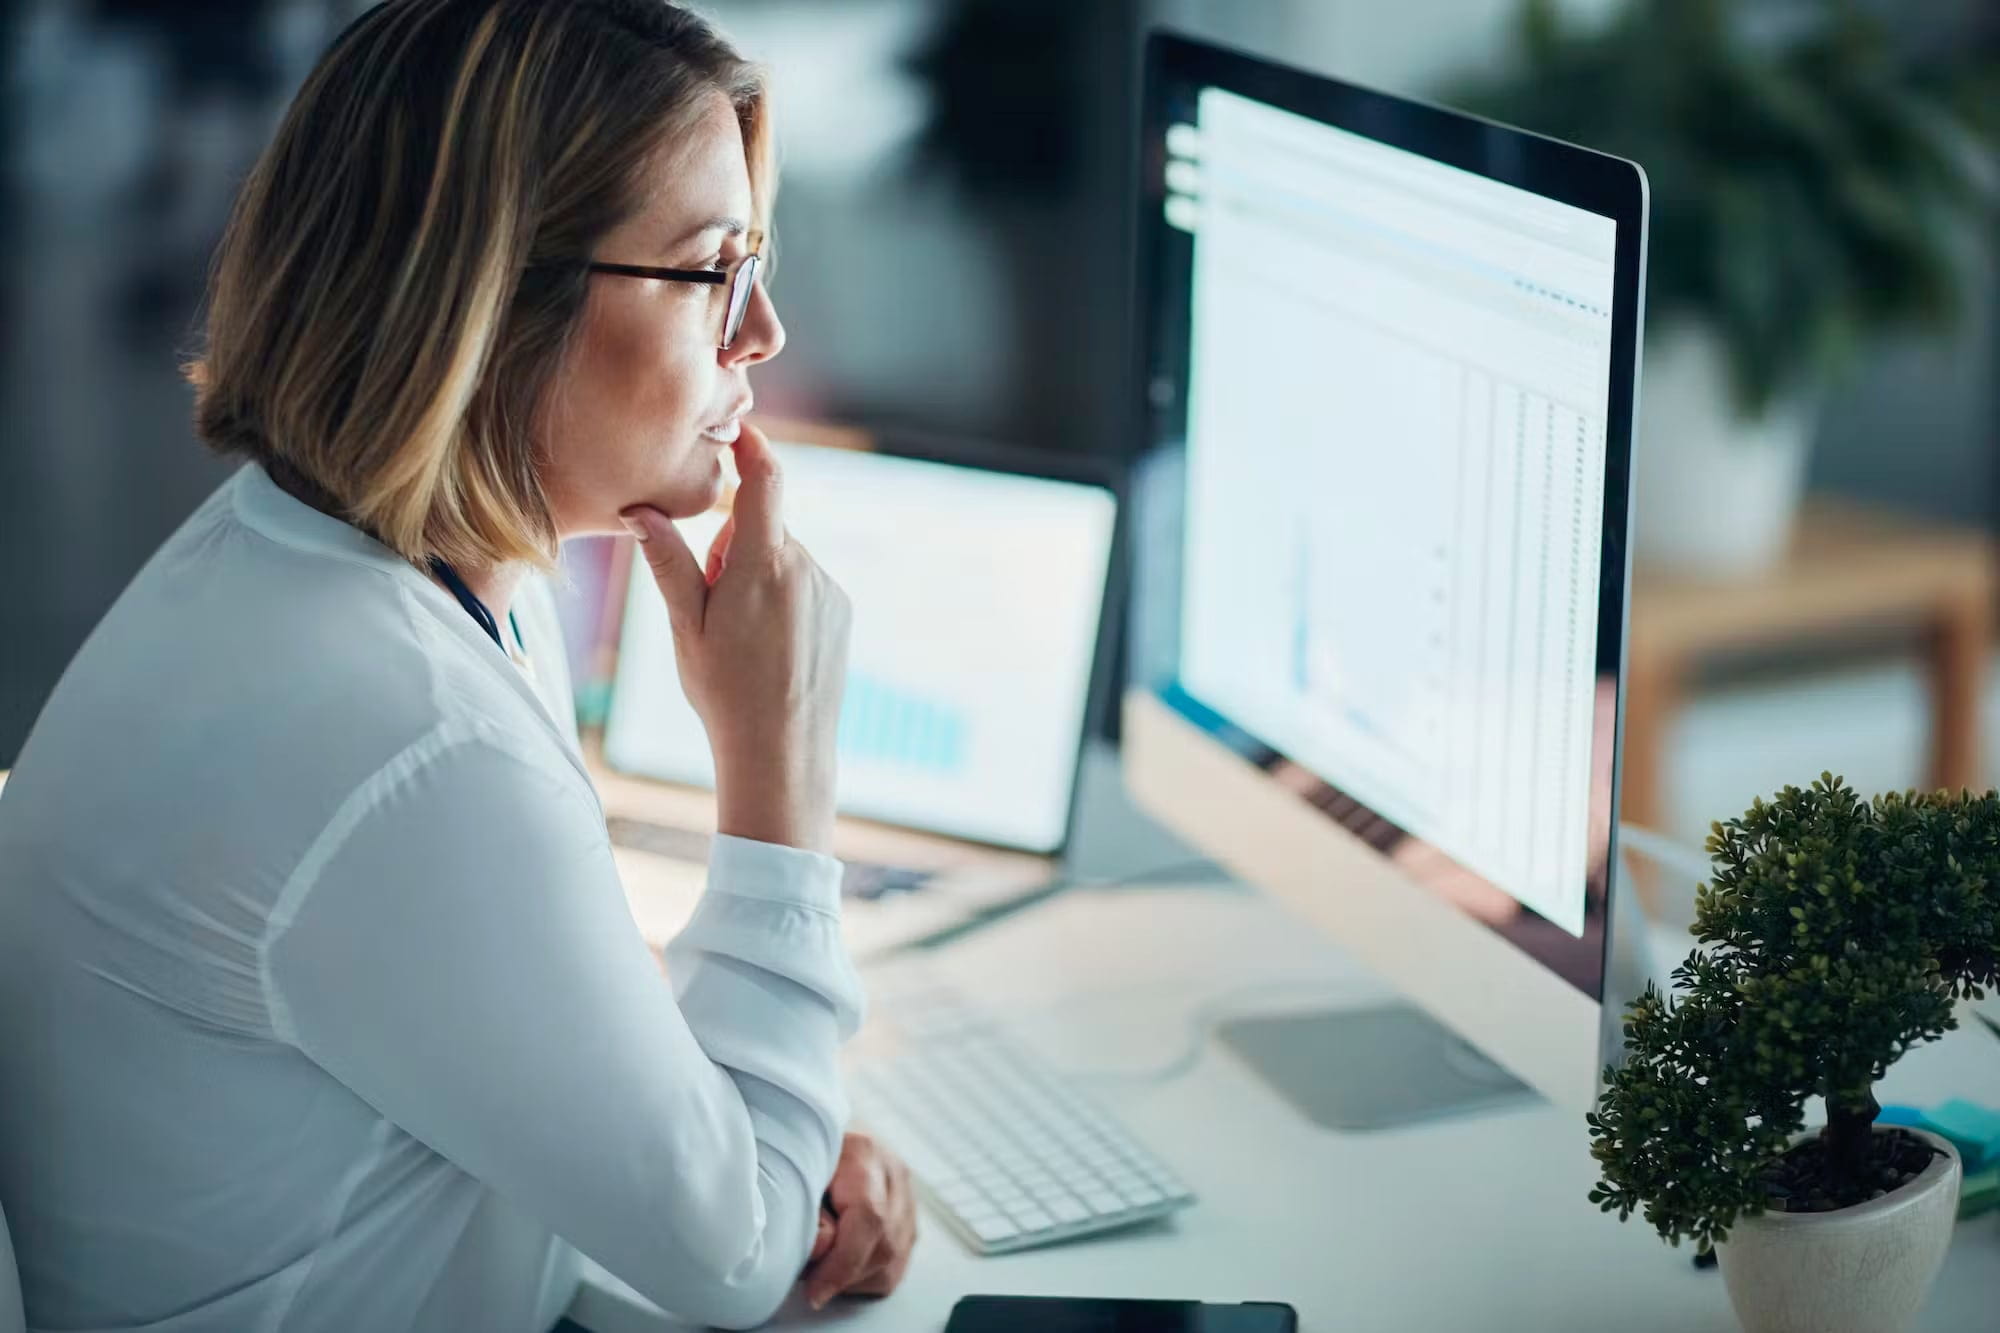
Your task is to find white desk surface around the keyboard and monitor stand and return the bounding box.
[570,883,2000,1333]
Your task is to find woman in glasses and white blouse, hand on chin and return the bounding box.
[0,0,914,1333]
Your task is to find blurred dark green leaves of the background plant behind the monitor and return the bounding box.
[1444,0,2000,414]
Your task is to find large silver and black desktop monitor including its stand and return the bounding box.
[1124,34,1646,1125]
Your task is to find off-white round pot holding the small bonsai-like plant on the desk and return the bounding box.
[1716,1125,1962,1333]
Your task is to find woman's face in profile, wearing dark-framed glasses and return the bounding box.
[542,92,784,538]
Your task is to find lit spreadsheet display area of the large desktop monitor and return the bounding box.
[1168,88,1616,935]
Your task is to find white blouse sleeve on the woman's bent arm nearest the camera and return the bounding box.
[264,737,862,1327]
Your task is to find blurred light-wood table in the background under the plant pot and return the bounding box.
[1622,492,1996,844]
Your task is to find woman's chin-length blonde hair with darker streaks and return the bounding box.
[186,0,776,566]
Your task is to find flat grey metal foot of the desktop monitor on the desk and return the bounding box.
[1216,1005,1536,1131]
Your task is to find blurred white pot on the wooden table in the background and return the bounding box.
[1632,322,1818,578]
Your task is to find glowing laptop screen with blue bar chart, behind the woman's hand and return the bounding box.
[604,444,1116,855]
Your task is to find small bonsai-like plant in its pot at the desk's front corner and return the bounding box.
[1590,775,2000,1333]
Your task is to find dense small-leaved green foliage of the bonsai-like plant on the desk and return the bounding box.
[1588,775,2000,1249]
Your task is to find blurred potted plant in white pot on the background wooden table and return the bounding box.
[1446,0,2000,574]
